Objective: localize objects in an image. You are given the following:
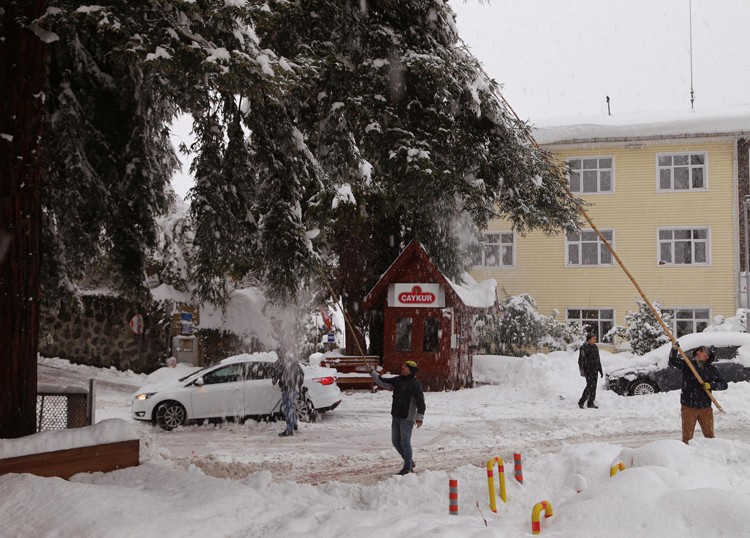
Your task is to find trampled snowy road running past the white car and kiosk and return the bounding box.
[39,356,750,484]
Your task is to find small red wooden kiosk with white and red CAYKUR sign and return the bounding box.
[361,241,497,390]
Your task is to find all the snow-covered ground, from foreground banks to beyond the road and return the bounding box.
[0,352,750,537]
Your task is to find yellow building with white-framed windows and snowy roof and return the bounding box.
[472,116,750,337]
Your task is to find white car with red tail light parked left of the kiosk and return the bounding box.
[132,354,341,430]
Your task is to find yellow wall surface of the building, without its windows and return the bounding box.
[472,138,737,324]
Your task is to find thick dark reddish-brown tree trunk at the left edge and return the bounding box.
[0,0,46,438]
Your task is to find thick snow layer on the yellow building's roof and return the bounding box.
[533,104,750,144]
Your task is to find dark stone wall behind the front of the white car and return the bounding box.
[39,295,171,372]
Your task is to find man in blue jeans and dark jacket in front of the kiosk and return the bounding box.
[370,361,426,475]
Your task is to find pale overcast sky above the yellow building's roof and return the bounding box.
[450,0,750,125]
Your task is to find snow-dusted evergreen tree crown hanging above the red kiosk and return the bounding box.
[257,0,578,326]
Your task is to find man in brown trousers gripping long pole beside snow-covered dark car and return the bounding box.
[669,341,727,444]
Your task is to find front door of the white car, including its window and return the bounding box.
[191,363,245,418]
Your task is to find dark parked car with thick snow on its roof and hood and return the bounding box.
[605,331,750,396]
